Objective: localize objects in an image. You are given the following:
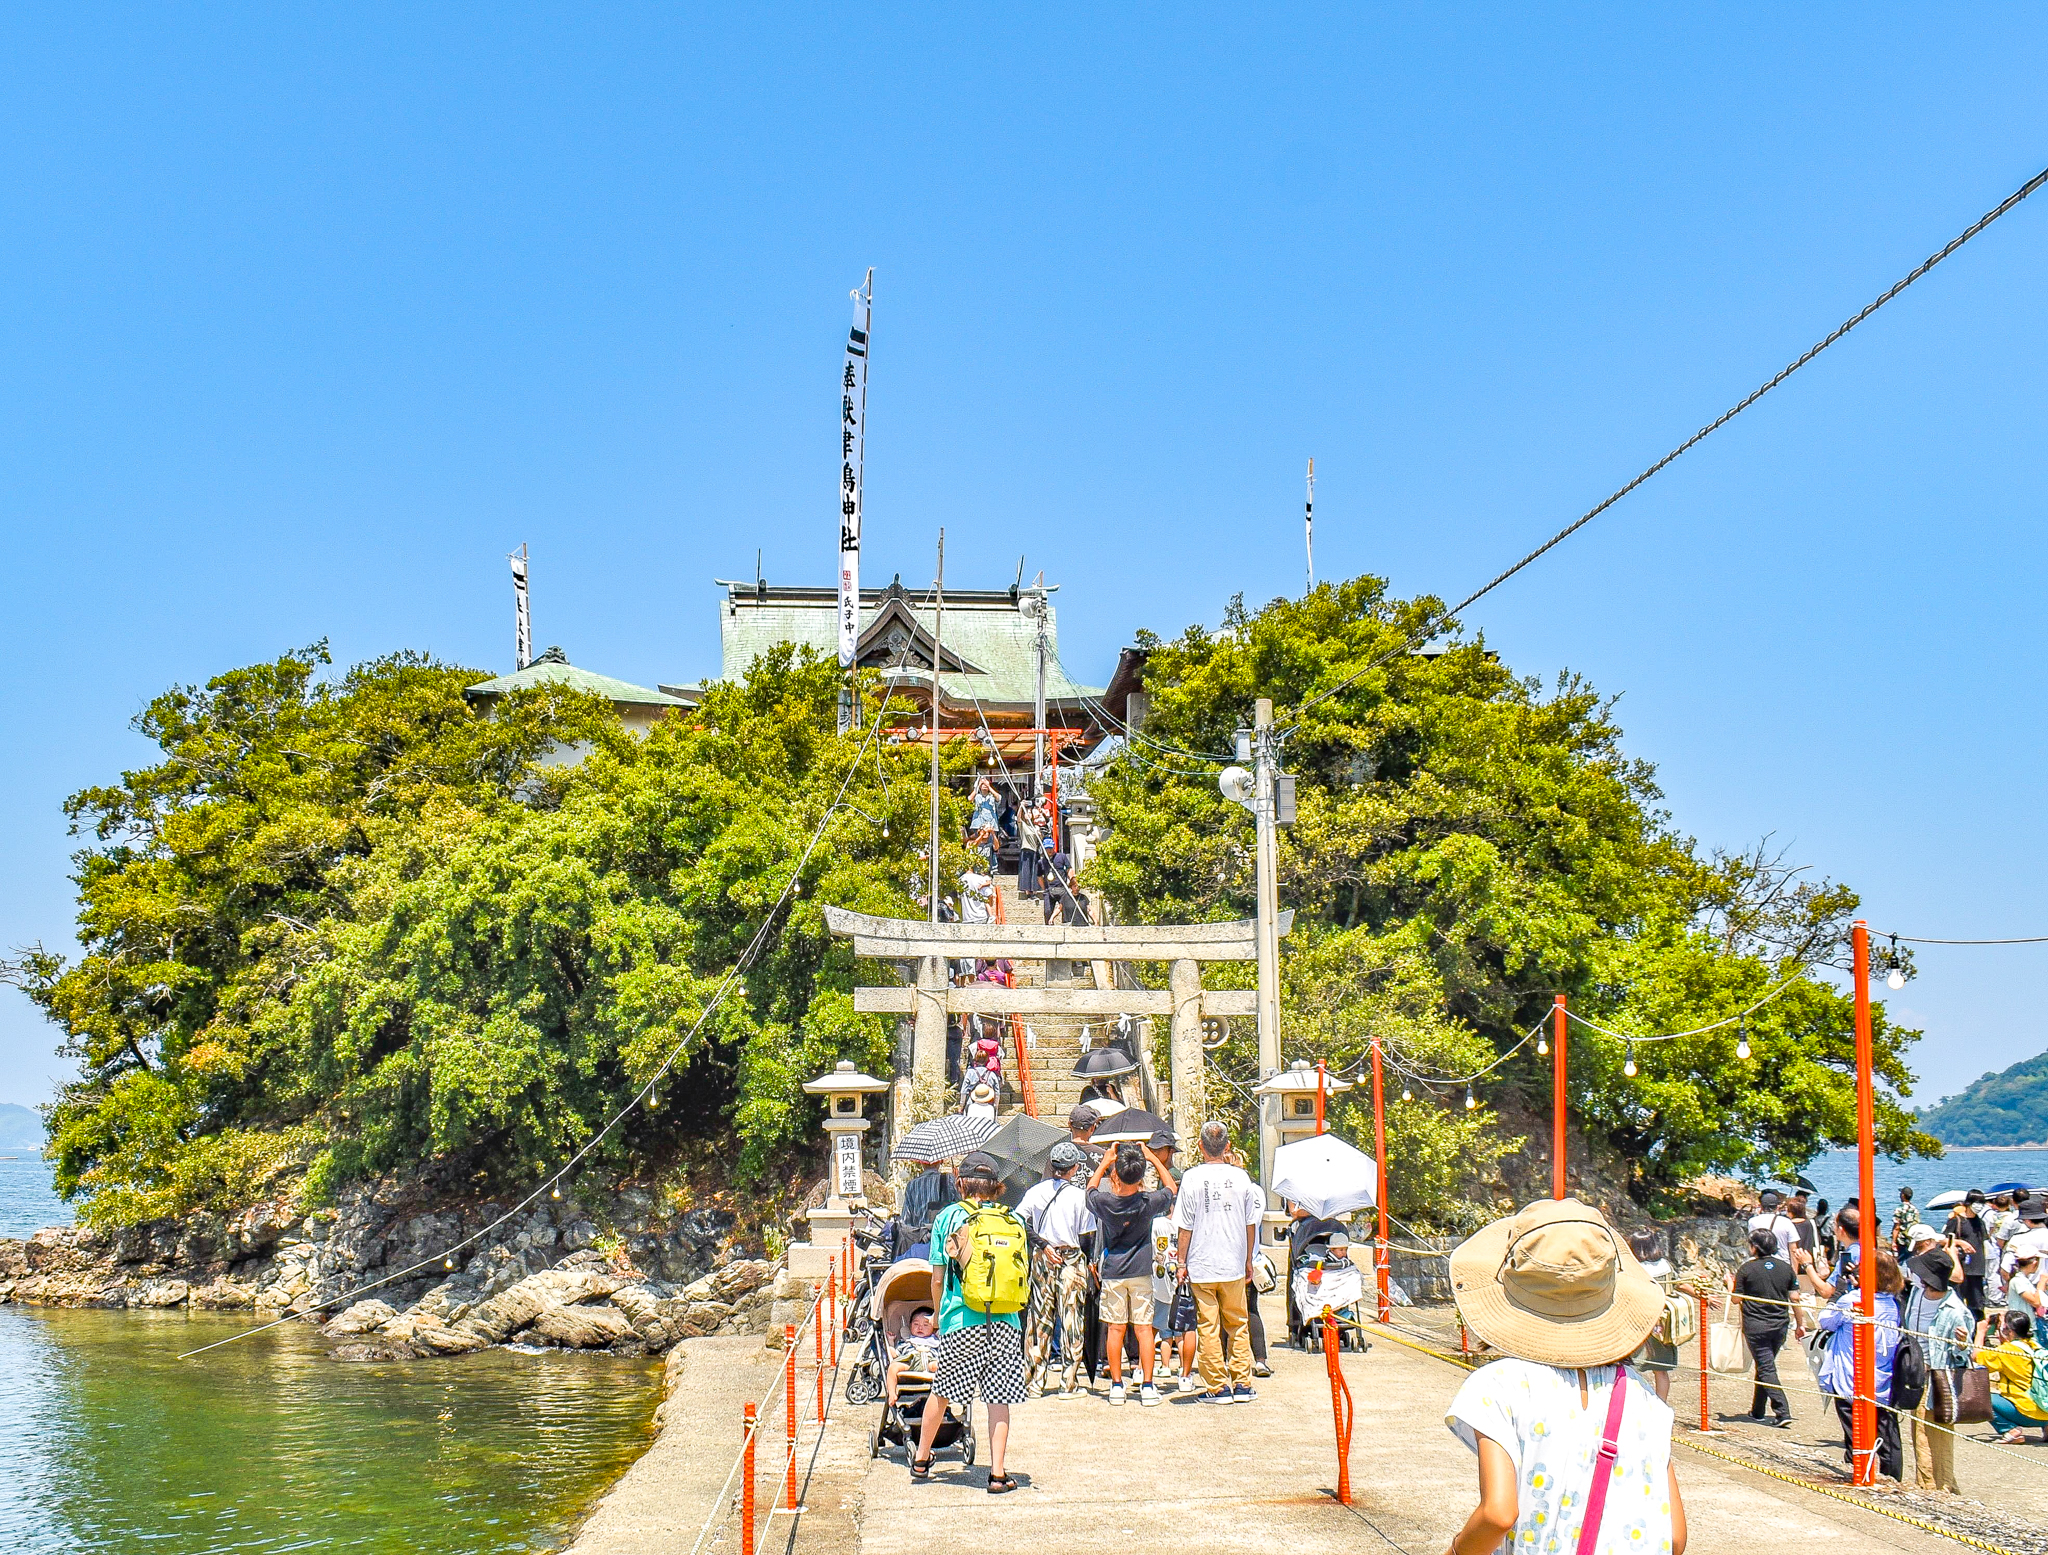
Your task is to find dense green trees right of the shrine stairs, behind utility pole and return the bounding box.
[1094,578,1937,1221]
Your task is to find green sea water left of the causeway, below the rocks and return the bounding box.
[0,1307,659,1555]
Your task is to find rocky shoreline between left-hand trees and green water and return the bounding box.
[0,1184,782,1360]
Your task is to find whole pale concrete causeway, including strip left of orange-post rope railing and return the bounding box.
[571,1301,2023,1555]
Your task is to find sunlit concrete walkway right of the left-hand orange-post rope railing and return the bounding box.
[782,1303,1958,1555]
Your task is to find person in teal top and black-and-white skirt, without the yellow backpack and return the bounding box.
[909,1149,1026,1496]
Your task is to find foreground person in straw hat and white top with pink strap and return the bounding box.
[1444,1199,1686,1555]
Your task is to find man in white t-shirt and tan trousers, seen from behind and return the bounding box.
[1174,1123,1266,1403]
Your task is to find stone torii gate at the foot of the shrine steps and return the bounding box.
[825,908,1294,1151]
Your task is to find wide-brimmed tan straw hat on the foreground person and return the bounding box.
[1450,1199,1663,1367]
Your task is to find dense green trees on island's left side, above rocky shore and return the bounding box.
[10,649,926,1223]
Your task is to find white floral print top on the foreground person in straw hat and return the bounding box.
[1444,1360,1671,1555]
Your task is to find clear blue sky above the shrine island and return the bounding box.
[0,6,2048,1102]
